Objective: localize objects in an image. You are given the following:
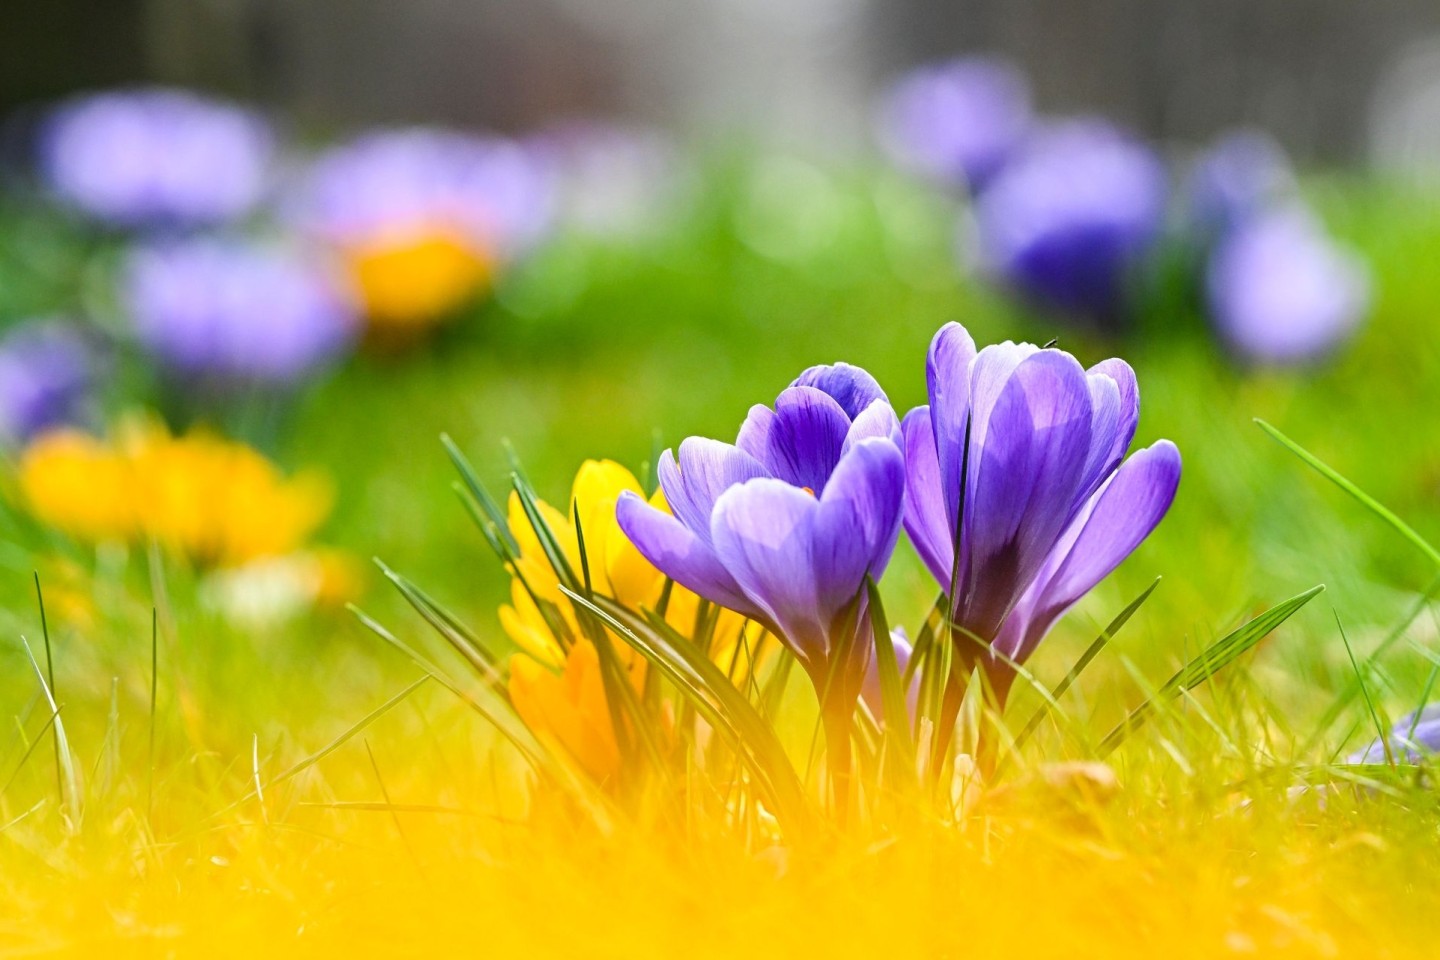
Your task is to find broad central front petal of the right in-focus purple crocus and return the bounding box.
[955,350,1093,638]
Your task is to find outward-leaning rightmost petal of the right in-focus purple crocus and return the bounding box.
[996,440,1181,661]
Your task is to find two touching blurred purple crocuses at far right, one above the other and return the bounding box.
[1188,132,1369,364]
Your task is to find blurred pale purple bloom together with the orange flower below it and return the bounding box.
[289,128,552,328]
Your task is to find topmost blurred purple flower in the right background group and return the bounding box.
[880,56,1031,191]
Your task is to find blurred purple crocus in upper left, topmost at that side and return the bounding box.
[40,89,274,227]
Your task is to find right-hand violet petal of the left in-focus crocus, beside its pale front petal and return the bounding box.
[811,438,904,619]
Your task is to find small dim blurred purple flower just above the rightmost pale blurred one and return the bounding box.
[1185,131,1296,243]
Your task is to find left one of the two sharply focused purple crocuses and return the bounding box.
[616,364,904,694]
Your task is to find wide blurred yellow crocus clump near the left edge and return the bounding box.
[19,423,330,567]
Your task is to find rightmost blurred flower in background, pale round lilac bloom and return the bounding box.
[1205,209,1369,364]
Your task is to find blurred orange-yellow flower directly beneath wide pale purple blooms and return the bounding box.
[347,227,495,331]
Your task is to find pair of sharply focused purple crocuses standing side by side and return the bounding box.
[616,324,1181,736]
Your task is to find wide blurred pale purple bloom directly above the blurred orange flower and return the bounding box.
[291,128,553,255]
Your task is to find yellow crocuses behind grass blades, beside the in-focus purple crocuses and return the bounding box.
[500,461,762,780]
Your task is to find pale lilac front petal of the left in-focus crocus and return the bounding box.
[710,478,828,664]
